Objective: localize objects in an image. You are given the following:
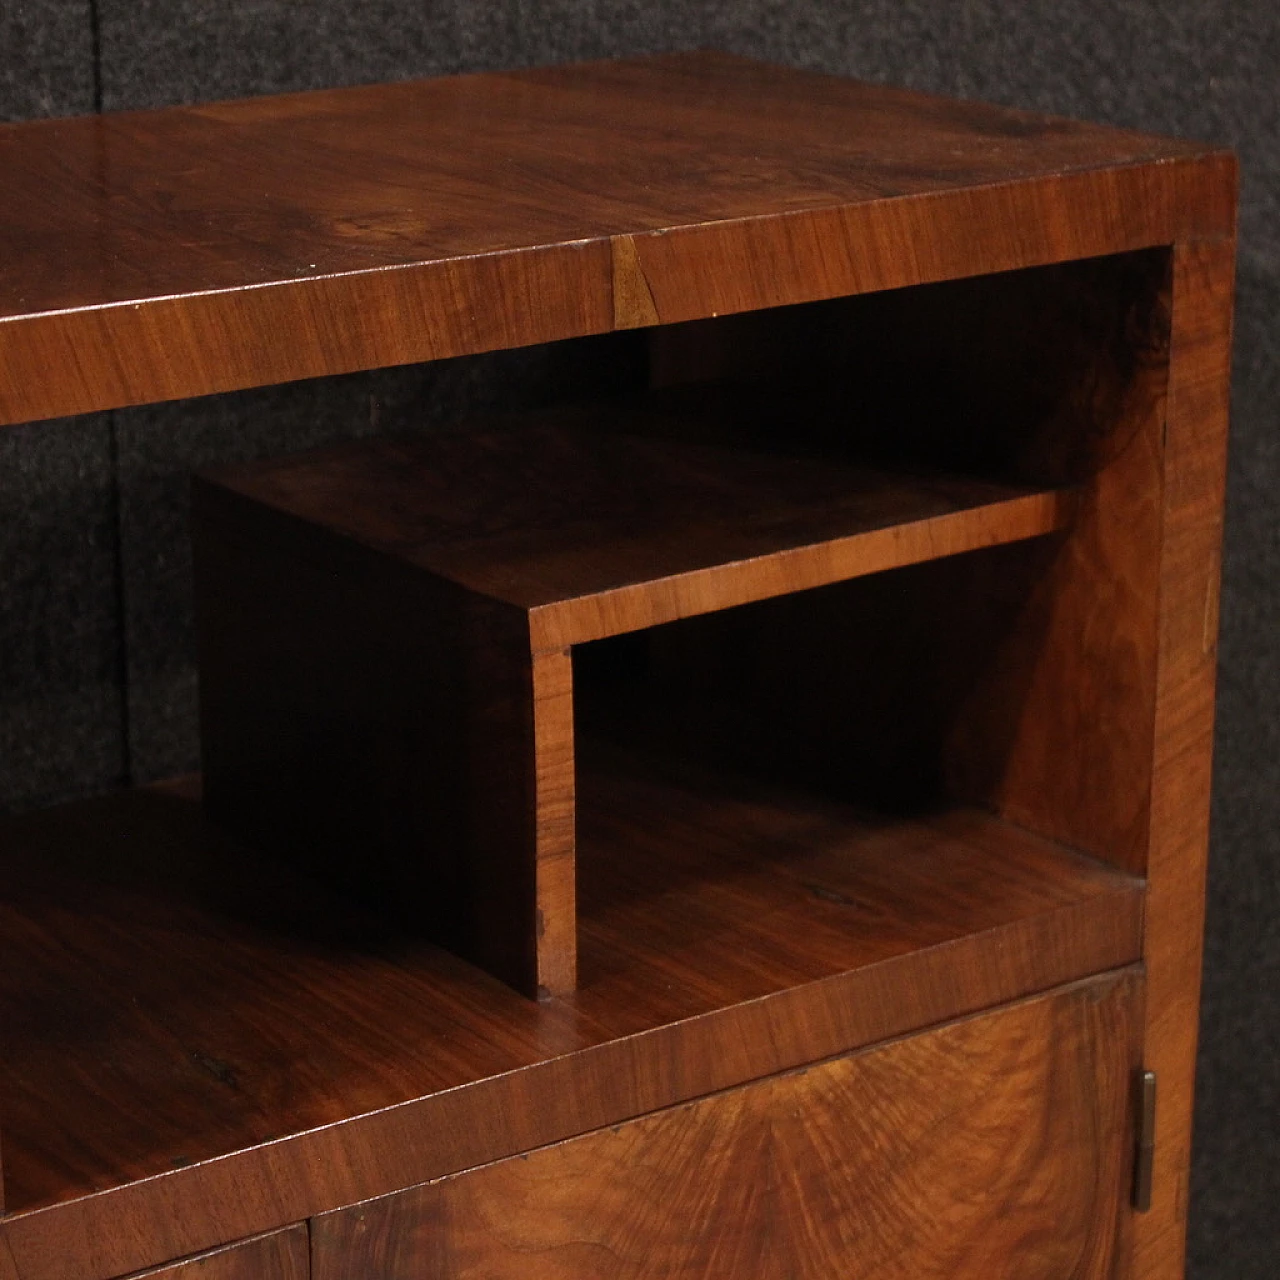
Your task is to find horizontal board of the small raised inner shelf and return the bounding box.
[202,404,1074,649]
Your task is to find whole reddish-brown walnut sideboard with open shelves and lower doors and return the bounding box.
[0,52,1235,1280]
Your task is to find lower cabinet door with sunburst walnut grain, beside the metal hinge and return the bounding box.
[312,972,1140,1280]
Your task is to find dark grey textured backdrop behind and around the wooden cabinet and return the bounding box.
[0,0,1280,1280]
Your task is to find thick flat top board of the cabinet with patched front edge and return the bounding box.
[0,52,1235,424]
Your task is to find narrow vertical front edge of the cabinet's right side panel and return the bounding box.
[1134,241,1235,1280]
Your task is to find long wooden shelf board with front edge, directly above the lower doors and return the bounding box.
[0,762,1142,1280]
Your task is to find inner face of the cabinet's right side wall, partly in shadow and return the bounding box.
[654,251,1169,872]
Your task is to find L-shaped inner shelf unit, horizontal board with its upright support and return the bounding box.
[186,394,1074,996]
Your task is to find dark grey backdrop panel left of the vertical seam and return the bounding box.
[0,0,123,809]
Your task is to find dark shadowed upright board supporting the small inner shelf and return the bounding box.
[192,486,555,996]
